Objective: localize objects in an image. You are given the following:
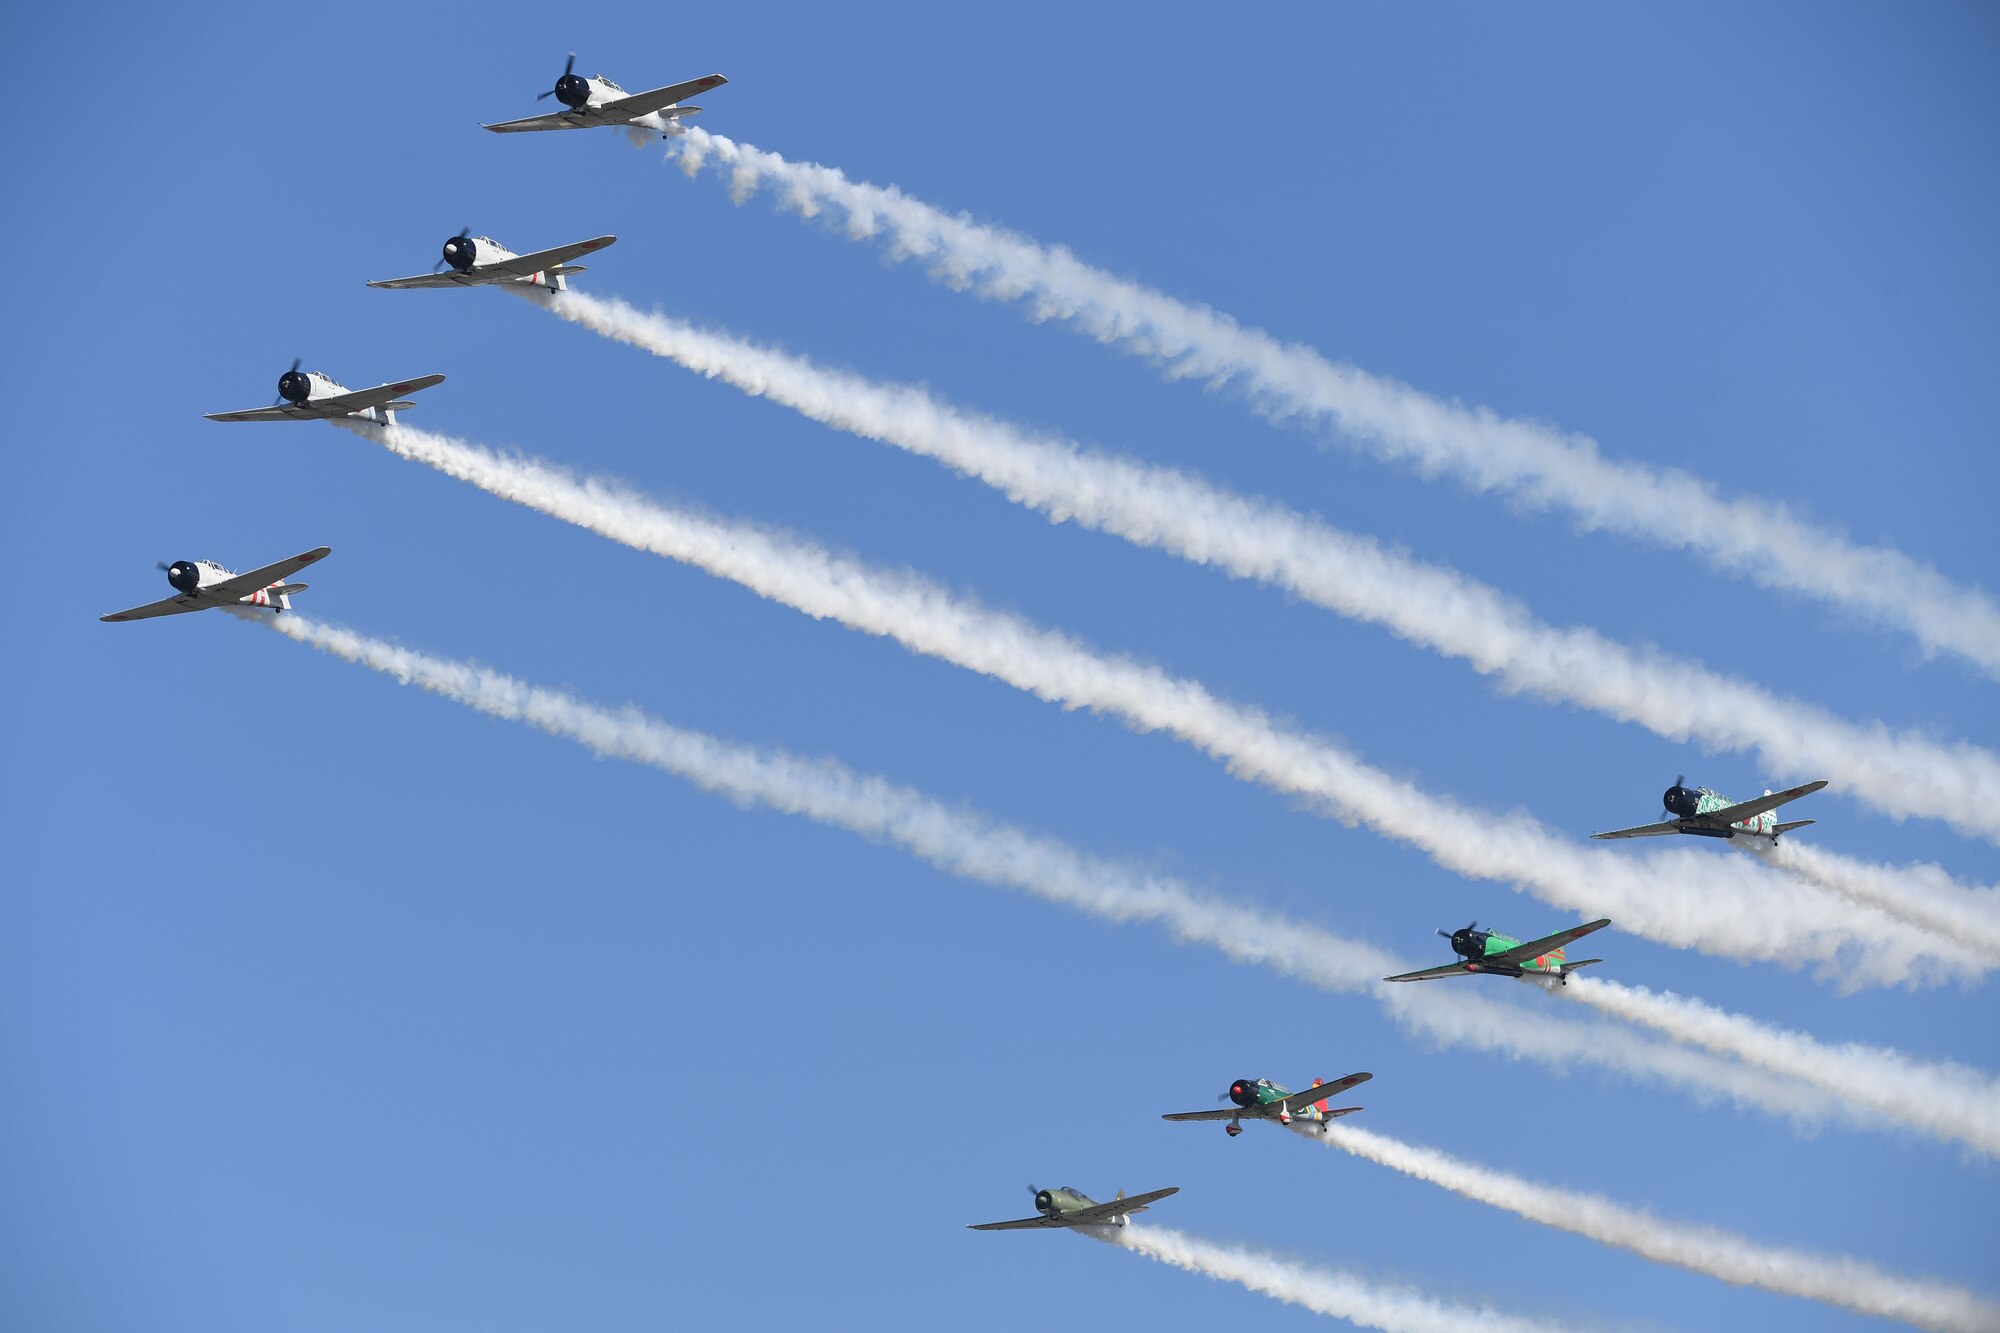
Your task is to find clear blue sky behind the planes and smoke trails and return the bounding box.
[0,0,2000,1333]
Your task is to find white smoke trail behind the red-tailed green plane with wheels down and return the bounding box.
[1312,1121,2000,1333]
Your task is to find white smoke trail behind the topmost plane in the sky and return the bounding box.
[670,128,2000,679]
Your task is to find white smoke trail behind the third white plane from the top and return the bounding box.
[352,416,1992,987]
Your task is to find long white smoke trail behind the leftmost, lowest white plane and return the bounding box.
[256,612,1848,1127]
